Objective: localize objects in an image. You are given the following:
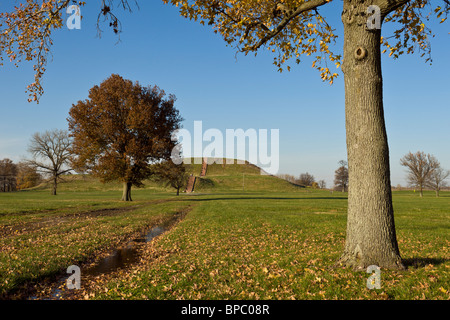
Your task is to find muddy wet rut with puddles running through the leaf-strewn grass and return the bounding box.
[3,205,192,300]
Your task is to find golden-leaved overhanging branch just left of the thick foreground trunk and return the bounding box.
[163,0,341,83]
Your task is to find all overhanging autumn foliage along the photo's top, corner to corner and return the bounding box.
[0,0,450,101]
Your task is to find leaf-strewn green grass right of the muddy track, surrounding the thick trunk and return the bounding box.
[82,192,450,299]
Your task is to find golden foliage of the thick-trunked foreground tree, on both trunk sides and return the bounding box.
[163,0,450,83]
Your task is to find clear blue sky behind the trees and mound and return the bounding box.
[0,0,450,187]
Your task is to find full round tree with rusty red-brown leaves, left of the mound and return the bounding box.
[68,74,182,201]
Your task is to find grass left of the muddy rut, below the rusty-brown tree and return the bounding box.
[0,191,188,296]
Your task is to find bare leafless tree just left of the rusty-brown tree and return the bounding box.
[26,129,72,195]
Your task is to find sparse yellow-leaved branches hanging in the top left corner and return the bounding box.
[0,0,137,103]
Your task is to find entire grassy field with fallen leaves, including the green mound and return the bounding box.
[0,165,450,300]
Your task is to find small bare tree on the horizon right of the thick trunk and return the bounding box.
[400,151,440,197]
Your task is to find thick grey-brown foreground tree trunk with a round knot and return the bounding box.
[339,0,403,269]
